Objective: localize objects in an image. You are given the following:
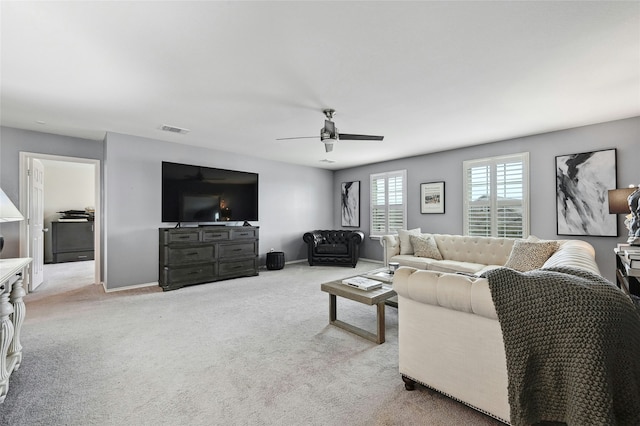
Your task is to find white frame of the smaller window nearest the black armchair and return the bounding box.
[369,170,407,238]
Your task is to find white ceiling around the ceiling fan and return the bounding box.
[0,1,640,169]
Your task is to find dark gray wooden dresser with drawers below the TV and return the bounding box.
[158,226,259,291]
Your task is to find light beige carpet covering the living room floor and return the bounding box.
[0,261,500,425]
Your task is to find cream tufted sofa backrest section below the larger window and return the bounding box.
[433,234,515,265]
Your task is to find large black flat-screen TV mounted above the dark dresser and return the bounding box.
[162,161,258,223]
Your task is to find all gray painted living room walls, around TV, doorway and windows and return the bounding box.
[0,117,640,288]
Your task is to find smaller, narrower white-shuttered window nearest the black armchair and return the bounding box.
[369,170,407,237]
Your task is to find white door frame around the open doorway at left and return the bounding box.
[18,151,103,288]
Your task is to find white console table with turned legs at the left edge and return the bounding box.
[0,257,32,402]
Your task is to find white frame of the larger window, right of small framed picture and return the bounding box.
[462,152,530,238]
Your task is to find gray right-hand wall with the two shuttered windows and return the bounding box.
[333,117,640,282]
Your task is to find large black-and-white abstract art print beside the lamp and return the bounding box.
[556,149,618,237]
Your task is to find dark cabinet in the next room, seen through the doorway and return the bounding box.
[51,220,95,263]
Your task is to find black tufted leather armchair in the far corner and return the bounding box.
[302,230,364,268]
